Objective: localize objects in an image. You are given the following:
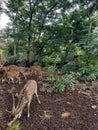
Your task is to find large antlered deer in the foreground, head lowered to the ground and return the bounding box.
[8,80,40,126]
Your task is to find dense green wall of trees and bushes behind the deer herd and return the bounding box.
[0,0,98,80]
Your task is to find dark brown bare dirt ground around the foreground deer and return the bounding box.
[0,74,98,130]
